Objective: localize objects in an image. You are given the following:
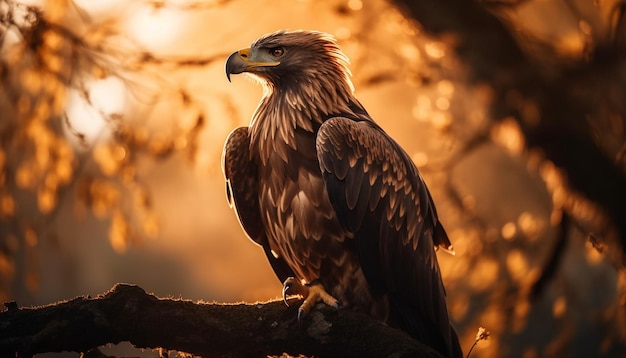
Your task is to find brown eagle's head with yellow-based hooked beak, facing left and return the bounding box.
[226,30,353,92]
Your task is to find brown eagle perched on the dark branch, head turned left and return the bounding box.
[222,30,462,357]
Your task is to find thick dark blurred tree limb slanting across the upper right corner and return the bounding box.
[395,0,626,266]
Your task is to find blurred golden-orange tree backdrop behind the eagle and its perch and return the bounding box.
[0,0,626,358]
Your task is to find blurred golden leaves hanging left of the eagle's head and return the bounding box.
[0,0,213,300]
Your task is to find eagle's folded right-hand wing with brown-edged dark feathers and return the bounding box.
[316,117,452,352]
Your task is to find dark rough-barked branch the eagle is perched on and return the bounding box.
[0,284,440,357]
